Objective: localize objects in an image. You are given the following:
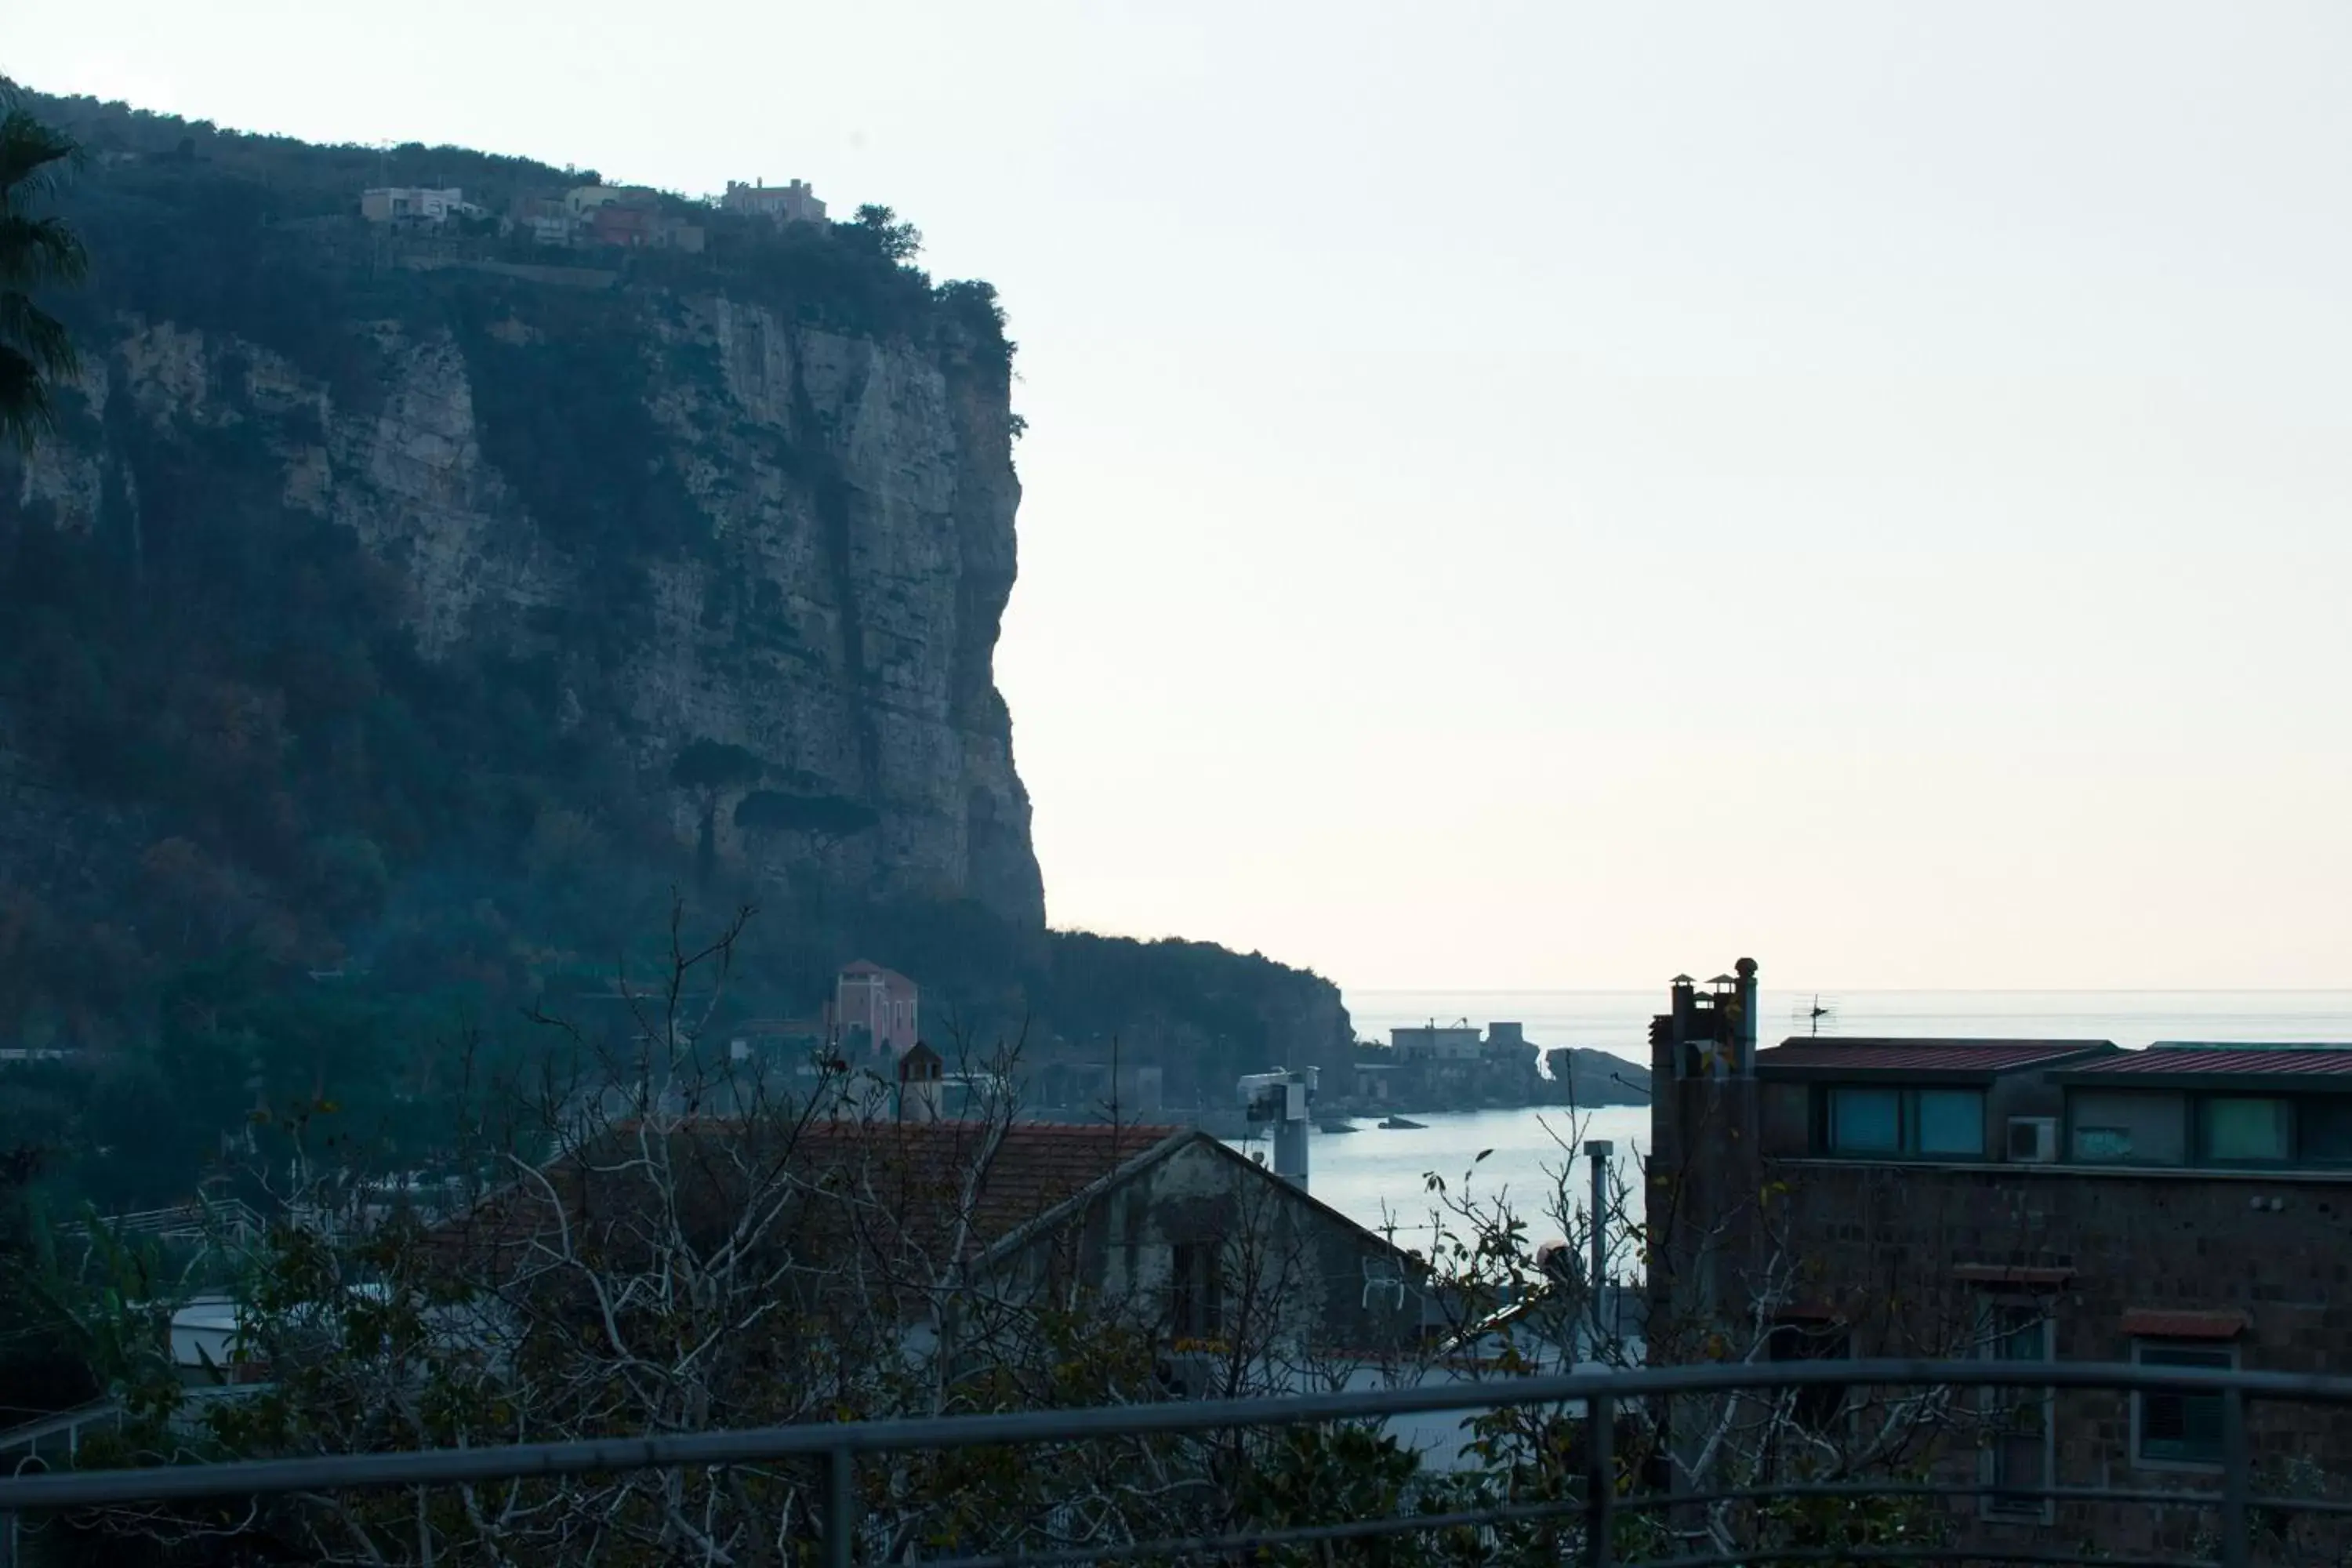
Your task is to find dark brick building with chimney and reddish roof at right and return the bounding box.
[1646,959,2352,1554]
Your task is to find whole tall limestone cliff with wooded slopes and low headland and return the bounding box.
[0,99,1350,1105]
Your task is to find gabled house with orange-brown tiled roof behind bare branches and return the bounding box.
[449,1114,1423,1392]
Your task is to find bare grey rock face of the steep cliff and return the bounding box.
[0,278,1044,926]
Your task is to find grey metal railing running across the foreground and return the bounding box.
[0,1361,2352,1568]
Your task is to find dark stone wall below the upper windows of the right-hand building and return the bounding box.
[1766,1159,2352,1559]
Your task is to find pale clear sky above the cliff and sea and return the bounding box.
[18,0,2352,987]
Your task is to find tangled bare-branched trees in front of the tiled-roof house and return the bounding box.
[55,912,1421,1568]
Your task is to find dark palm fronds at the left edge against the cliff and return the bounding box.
[0,80,89,452]
